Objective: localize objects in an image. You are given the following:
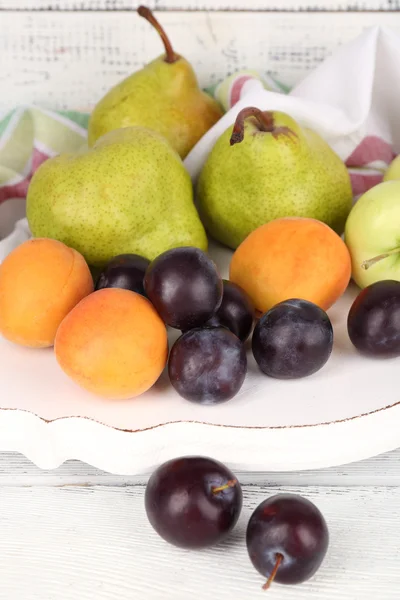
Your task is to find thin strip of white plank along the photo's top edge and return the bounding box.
[0,0,400,11]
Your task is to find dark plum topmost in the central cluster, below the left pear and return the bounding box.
[144,246,223,331]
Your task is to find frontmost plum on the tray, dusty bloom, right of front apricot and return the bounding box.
[168,327,247,404]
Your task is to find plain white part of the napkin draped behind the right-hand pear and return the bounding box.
[185,27,400,181]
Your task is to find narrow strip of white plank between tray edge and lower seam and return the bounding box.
[0,448,400,487]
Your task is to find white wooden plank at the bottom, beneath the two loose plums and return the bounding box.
[0,486,400,600]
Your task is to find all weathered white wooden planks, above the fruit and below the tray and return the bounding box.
[0,0,400,600]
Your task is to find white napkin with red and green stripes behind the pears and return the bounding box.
[0,27,400,251]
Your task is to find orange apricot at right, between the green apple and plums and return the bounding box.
[230,217,351,313]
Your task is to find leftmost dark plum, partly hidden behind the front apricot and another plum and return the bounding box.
[96,254,150,296]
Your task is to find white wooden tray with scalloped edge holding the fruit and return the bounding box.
[0,223,400,474]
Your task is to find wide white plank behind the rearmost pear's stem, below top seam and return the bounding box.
[0,12,400,110]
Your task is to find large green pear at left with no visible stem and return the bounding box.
[26,127,207,267]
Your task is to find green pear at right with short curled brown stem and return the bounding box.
[196,107,353,249]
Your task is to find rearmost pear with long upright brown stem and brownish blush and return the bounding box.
[89,6,222,159]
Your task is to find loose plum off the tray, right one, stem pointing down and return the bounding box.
[246,494,329,589]
